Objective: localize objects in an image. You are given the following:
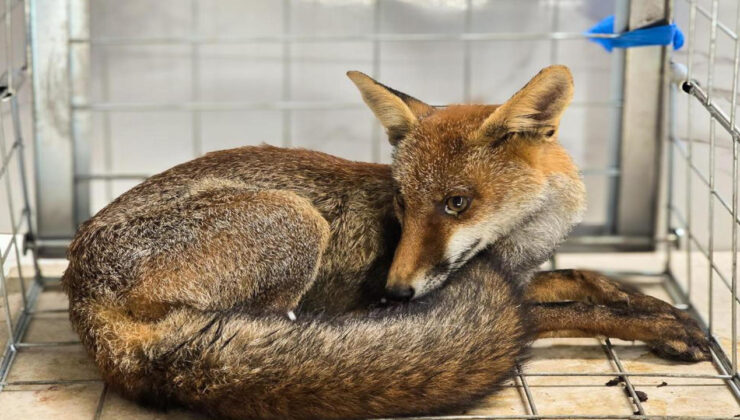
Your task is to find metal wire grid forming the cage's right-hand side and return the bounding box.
[666,0,740,396]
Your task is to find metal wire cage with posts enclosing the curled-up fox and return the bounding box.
[0,0,740,419]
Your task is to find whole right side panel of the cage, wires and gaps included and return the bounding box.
[666,0,740,408]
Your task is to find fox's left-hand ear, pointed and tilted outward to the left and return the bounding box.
[347,71,434,146]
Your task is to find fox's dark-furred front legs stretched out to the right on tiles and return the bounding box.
[525,270,711,361]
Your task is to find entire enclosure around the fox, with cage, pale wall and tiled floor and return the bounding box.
[0,0,740,419]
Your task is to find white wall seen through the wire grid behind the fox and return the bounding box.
[82,0,613,230]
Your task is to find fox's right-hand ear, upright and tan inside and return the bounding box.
[478,66,573,142]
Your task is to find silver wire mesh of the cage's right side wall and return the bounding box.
[668,0,740,378]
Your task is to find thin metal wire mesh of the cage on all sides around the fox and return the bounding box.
[0,0,740,419]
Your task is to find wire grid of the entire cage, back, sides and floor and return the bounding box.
[0,0,740,419]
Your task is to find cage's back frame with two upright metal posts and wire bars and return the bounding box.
[27,0,667,256]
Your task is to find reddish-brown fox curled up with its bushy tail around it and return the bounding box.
[62,65,710,419]
